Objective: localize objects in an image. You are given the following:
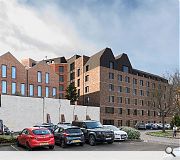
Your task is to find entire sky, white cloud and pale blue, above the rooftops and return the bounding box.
[0,0,179,75]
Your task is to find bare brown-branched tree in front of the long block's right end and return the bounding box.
[148,71,180,132]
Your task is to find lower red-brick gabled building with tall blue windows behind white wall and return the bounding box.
[0,52,59,98]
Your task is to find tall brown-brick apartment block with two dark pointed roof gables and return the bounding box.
[67,48,168,126]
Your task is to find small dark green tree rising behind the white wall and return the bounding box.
[66,84,78,104]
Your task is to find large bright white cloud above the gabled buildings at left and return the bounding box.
[0,0,96,59]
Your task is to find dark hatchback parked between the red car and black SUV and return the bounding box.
[54,125,84,148]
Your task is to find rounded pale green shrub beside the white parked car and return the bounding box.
[121,126,140,140]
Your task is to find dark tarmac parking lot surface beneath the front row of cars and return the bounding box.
[0,141,176,151]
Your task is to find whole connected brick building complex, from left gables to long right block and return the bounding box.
[0,48,172,126]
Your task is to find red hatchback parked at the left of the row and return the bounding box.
[17,127,54,150]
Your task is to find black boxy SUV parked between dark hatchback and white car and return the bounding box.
[72,120,114,146]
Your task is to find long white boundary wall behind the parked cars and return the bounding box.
[0,95,100,131]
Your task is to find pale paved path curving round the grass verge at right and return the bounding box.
[141,131,180,146]
